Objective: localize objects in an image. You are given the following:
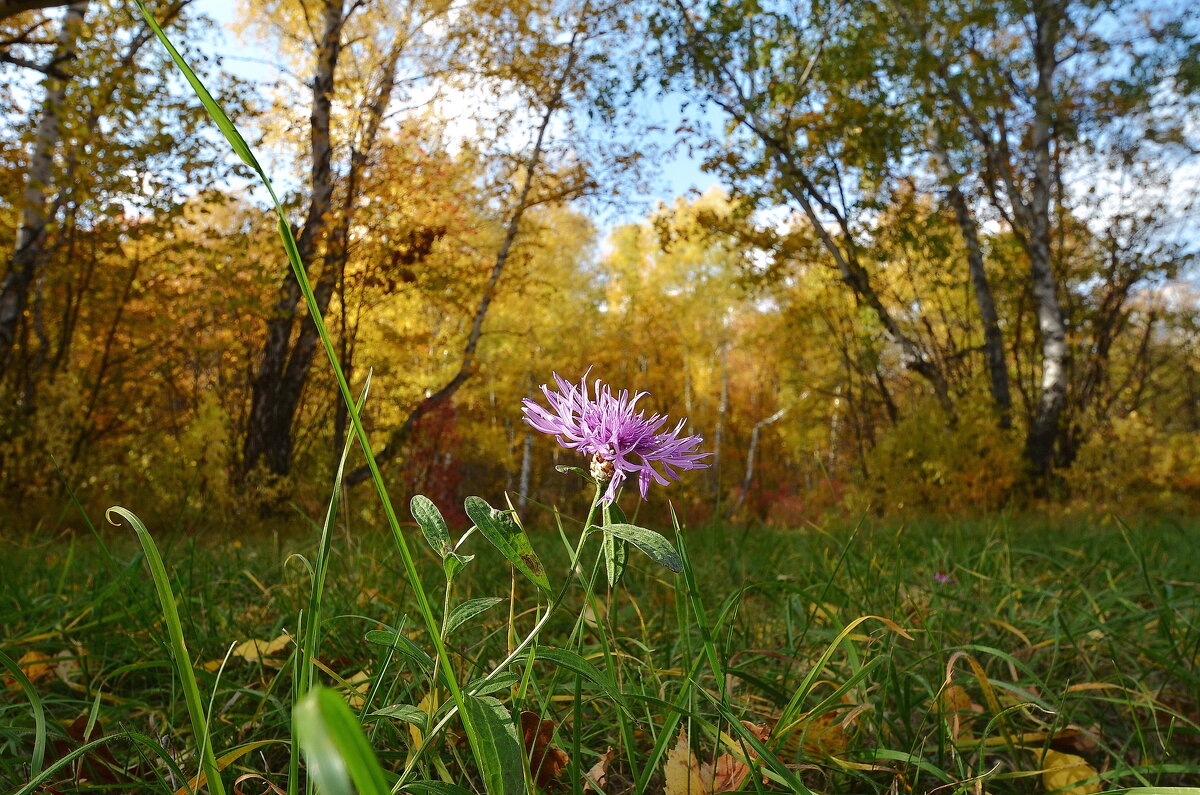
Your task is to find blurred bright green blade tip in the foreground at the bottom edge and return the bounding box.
[292,687,388,795]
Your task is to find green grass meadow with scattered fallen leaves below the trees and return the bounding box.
[0,512,1200,794]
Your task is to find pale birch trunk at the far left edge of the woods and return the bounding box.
[0,0,88,386]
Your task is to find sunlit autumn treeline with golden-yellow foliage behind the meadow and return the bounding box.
[0,0,1200,524]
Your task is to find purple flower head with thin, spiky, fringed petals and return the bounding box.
[521,370,712,503]
